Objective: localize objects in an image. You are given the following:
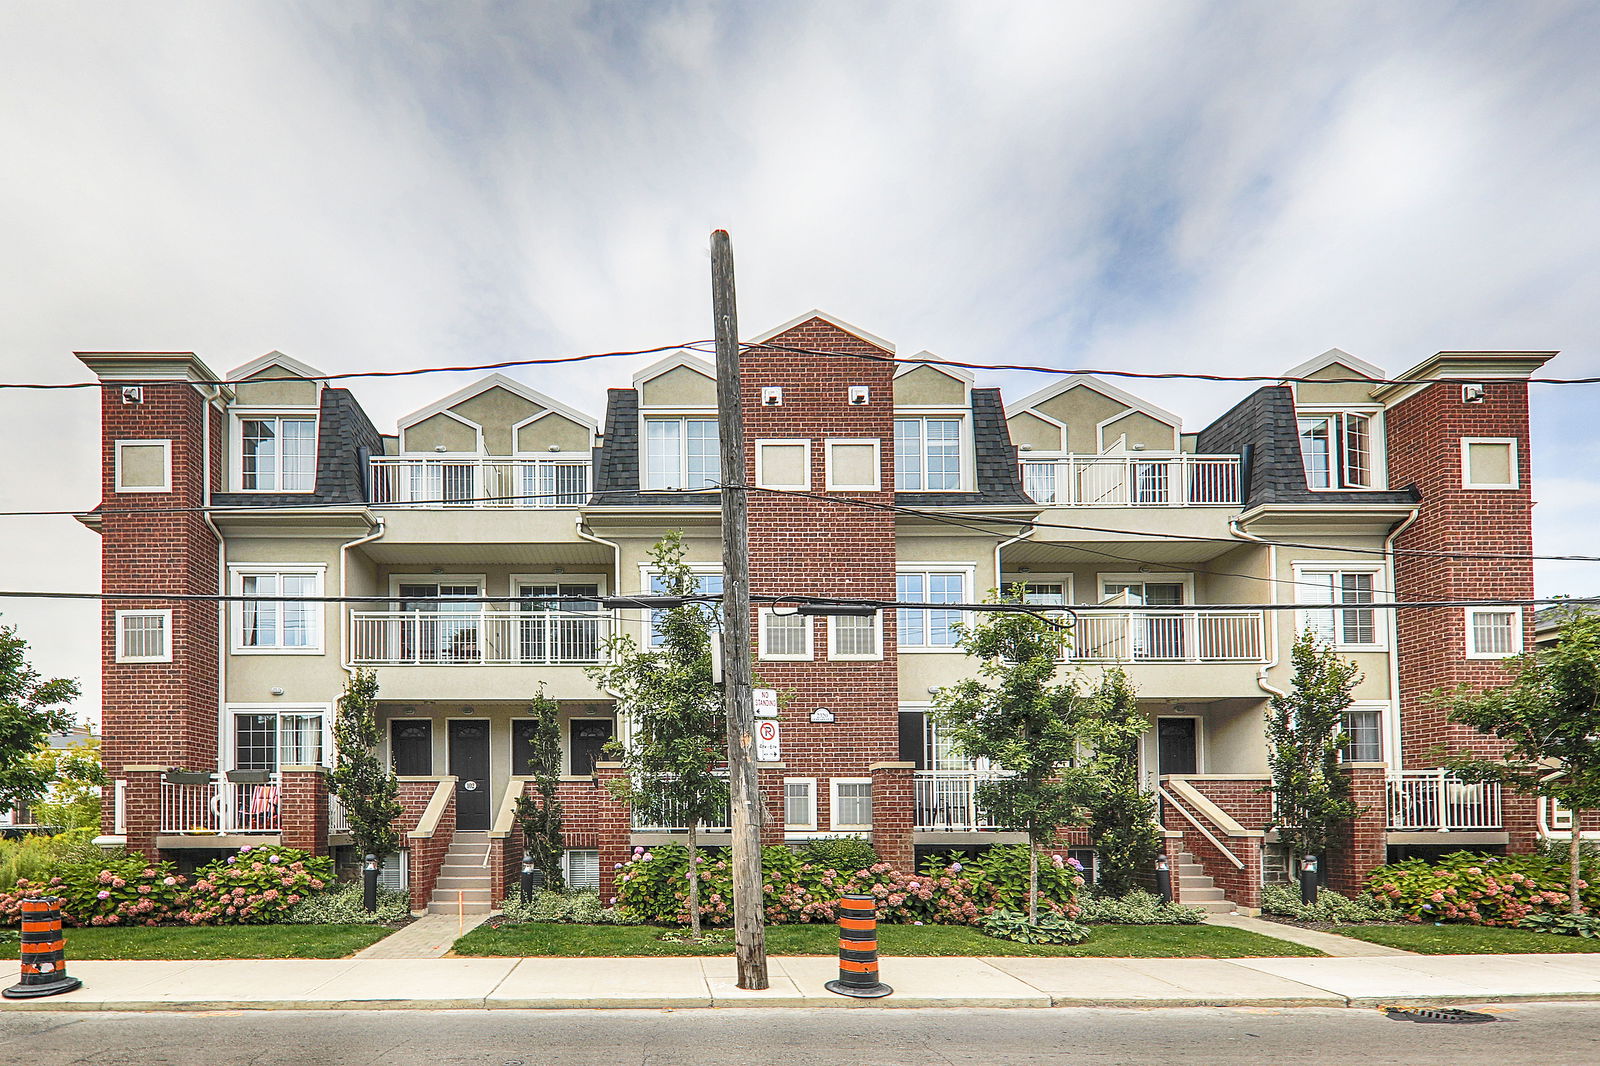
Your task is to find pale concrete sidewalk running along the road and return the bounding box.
[0,954,1600,1012]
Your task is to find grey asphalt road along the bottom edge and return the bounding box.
[0,1004,1600,1066]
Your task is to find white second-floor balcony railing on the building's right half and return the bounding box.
[1072,610,1266,663]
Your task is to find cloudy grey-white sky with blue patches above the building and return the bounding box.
[0,0,1600,706]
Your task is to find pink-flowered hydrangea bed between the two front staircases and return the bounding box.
[613,844,1083,925]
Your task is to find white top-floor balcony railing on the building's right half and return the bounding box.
[1022,455,1240,507]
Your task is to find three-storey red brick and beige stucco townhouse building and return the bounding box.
[78,312,1552,911]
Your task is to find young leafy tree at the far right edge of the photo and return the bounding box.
[1434,610,1600,914]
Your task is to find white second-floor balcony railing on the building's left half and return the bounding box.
[349,608,611,666]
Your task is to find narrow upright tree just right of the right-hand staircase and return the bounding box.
[1267,629,1362,855]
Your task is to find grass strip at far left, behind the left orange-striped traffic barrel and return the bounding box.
[5,925,394,967]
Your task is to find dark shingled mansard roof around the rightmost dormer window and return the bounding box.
[1195,386,1421,509]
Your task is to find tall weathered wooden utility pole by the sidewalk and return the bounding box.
[710,229,766,991]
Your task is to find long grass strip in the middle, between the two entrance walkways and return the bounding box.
[456,922,1322,959]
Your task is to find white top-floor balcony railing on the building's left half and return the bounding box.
[370,456,589,507]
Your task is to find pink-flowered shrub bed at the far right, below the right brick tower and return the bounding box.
[1366,852,1600,925]
